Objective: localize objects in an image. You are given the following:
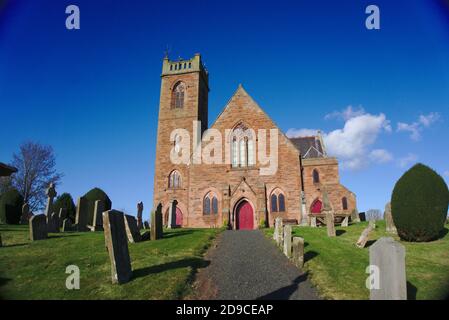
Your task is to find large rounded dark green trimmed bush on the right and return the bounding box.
[391,164,449,242]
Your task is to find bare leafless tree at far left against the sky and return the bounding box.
[12,142,63,211]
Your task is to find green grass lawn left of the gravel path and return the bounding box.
[0,225,221,299]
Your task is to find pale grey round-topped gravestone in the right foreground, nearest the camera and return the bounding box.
[369,237,407,300]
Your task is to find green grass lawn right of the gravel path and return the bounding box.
[265,221,449,300]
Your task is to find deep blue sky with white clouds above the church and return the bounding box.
[0,0,449,216]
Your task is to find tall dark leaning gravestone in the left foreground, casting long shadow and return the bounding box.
[103,210,132,284]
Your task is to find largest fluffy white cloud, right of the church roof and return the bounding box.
[287,107,393,170]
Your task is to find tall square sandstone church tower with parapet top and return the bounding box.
[153,54,209,225]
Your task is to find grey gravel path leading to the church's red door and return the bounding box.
[195,230,319,300]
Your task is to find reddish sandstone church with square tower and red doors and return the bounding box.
[153,54,356,229]
